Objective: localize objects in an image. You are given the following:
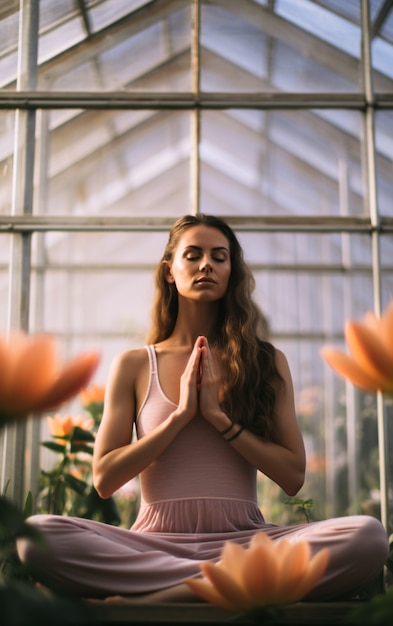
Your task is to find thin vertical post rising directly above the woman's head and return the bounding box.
[190,0,201,214]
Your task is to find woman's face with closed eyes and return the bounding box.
[166,224,231,302]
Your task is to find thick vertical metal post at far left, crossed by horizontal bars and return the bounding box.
[1,0,39,504]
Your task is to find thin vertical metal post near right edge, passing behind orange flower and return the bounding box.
[361,0,388,529]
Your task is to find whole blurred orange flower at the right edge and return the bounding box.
[321,302,393,394]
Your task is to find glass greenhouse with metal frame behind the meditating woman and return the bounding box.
[0,0,393,604]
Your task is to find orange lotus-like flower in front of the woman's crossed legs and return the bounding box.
[184,532,329,612]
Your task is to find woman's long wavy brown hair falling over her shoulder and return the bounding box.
[147,213,284,439]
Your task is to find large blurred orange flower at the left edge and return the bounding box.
[0,331,100,423]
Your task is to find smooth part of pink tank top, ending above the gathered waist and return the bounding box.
[136,346,257,504]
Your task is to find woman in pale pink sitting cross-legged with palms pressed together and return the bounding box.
[19,214,388,601]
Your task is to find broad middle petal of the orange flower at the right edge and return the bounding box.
[345,322,393,387]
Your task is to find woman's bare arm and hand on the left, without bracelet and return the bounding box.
[93,348,199,498]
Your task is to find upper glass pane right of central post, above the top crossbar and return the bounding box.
[201,0,361,93]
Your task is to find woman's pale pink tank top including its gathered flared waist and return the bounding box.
[133,345,263,532]
